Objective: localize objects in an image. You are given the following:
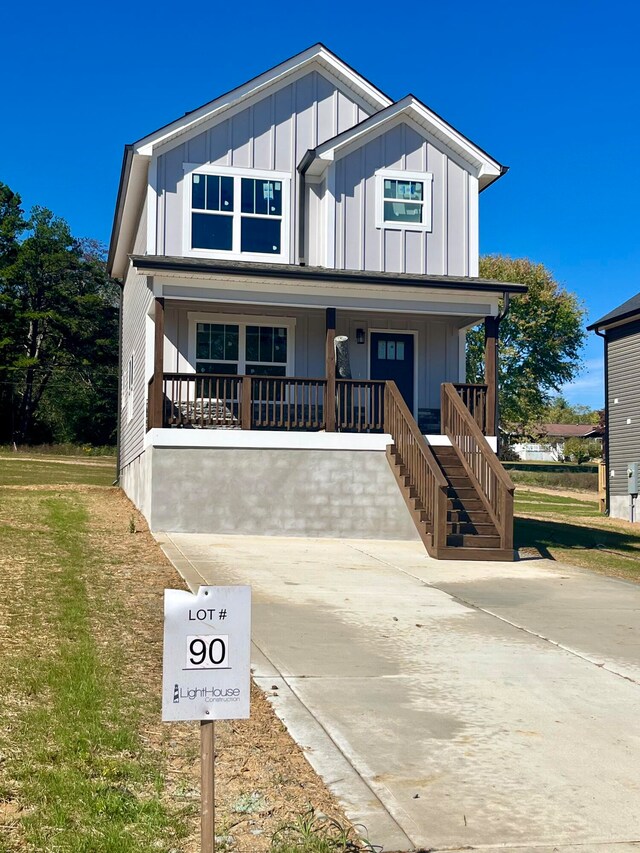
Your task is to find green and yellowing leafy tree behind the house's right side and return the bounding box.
[467,255,586,430]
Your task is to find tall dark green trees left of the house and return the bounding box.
[0,195,118,443]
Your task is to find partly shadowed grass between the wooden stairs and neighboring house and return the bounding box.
[515,491,640,581]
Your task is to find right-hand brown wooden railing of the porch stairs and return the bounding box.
[441,382,515,550]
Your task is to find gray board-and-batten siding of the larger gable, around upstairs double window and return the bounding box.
[157,71,368,262]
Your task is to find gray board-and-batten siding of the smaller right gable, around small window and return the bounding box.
[324,123,478,275]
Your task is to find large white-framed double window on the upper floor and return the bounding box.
[183,164,291,263]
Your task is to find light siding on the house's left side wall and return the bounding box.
[120,196,153,467]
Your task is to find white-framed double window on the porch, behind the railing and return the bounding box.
[189,313,296,376]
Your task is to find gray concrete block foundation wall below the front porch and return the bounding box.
[145,447,418,539]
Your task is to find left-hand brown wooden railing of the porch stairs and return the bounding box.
[384,380,449,550]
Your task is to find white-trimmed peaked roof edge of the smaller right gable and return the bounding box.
[298,95,508,190]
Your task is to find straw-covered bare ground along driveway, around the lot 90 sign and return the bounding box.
[0,485,362,853]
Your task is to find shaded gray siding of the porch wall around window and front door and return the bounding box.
[164,302,463,409]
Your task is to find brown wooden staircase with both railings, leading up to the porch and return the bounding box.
[385,382,514,560]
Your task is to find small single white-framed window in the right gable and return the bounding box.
[376,169,433,231]
